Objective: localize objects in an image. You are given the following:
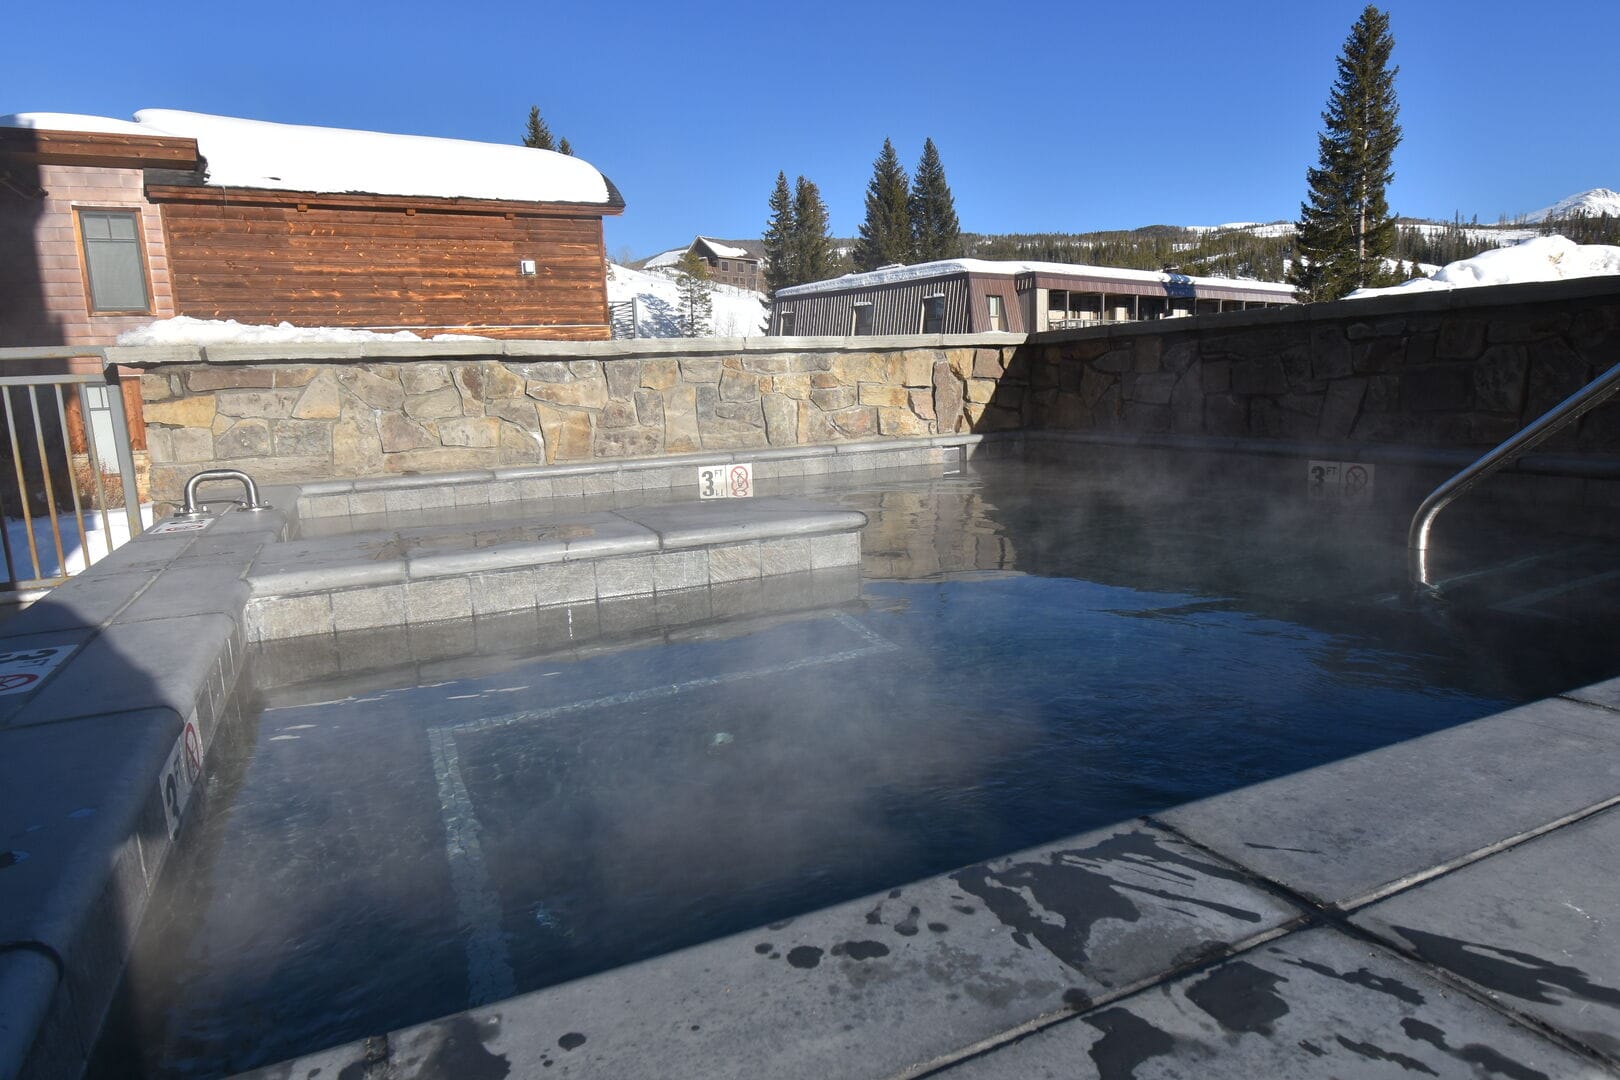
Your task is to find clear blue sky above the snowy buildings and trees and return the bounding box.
[0,0,1620,256]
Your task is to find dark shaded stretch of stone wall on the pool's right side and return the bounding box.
[1017,279,1620,452]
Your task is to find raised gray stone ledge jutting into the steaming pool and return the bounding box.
[246,497,867,641]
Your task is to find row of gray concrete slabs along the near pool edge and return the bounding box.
[245,680,1620,1080]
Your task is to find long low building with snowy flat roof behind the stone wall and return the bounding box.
[770,259,1294,337]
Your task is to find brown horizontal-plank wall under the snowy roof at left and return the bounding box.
[154,193,609,340]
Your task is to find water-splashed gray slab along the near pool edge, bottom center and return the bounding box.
[231,824,1298,1080]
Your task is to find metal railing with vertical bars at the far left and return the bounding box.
[0,348,143,599]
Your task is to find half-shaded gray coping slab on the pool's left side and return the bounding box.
[10,614,235,727]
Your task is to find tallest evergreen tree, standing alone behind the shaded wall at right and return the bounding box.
[1291,3,1401,300]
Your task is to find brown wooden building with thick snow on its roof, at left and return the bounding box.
[0,110,624,345]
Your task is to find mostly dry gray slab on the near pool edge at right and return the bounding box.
[1158,698,1620,907]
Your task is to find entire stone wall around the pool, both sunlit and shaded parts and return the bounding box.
[119,279,1620,504]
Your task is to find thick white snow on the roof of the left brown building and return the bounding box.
[0,108,624,207]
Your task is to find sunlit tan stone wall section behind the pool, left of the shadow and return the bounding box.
[118,335,997,504]
